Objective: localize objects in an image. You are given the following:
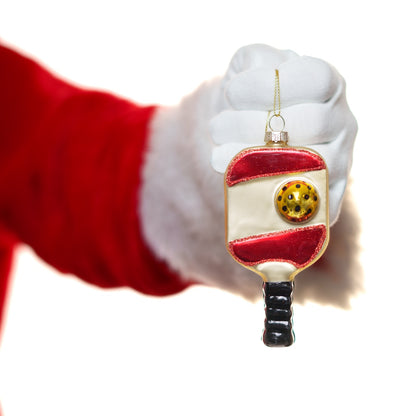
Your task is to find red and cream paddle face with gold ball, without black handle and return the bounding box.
[225,146,329,282]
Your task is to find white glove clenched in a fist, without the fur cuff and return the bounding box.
[210,45,357,225]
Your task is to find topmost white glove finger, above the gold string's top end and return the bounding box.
[224,44,299,83]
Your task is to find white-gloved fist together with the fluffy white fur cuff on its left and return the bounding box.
[139,45,357,298]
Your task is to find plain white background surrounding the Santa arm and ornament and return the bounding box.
[0,0,416,416]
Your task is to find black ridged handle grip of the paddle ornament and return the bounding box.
[263,282,295,347]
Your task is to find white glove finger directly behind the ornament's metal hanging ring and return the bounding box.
[209,99,349,146]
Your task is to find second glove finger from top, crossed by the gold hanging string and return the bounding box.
[225,56,343,111]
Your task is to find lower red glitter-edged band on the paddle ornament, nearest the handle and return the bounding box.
[229,225,326,268]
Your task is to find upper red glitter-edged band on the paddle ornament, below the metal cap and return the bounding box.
[226,147,326,186]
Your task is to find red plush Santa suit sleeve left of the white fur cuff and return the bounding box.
[0,45,192,330]
